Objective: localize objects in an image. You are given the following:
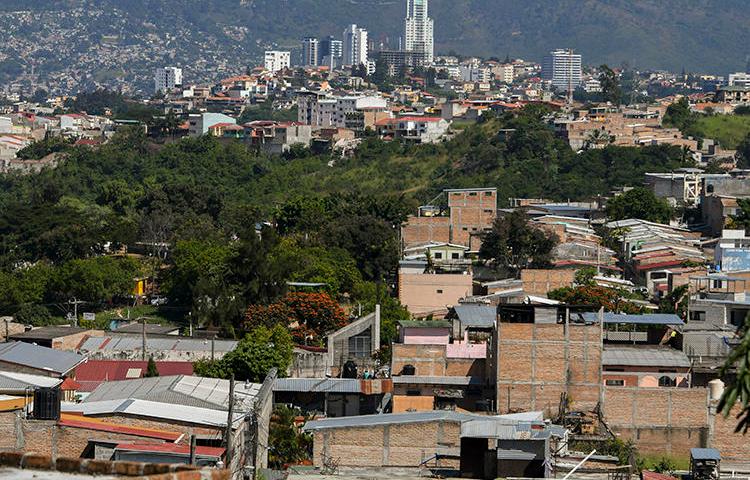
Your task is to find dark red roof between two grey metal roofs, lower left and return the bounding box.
[75,360,193,392]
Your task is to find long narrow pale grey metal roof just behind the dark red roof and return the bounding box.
[79,334,237,352]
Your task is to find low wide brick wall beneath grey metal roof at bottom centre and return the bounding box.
[313,421,461,468]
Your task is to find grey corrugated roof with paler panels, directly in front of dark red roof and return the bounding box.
[84,375,261,411]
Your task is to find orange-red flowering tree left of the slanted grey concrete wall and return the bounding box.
[245,292,347,345]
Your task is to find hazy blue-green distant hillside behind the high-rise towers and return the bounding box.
[0,0,750,92]
